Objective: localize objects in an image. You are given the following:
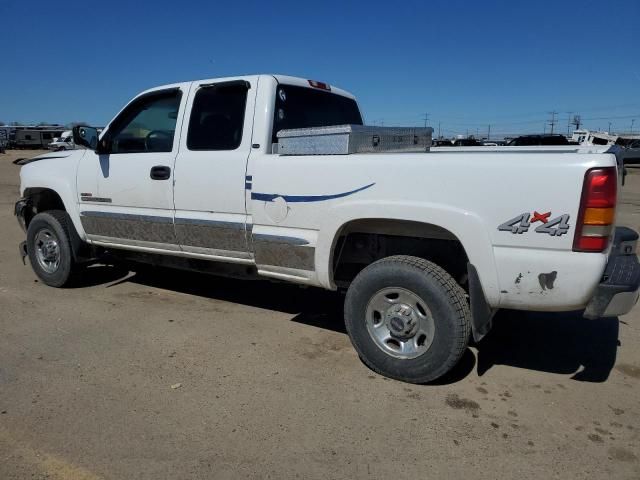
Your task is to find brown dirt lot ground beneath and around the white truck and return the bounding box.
[0,151,640,480]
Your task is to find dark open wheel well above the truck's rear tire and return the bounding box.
[332,219,469,289]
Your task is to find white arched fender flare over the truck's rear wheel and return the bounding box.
[316,200,500,306]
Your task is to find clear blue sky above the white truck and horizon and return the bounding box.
[0,0,640,135]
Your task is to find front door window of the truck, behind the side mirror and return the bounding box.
[109,91,181,153]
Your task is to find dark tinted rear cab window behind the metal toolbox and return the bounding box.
[273,85,362,143]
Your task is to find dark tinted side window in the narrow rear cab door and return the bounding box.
[187,81,249,150]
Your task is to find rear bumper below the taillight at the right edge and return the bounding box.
[584,227,640,318]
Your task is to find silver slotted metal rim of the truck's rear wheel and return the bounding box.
[366,287,435,359]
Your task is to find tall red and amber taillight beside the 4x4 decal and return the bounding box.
[573,167,618,252]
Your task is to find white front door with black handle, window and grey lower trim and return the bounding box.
[77,84,189,250]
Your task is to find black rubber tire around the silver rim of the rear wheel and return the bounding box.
[344,255,471,383]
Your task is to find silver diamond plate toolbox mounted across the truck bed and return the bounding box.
[278,125,433,155]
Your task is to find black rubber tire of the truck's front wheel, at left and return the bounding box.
[27,210,80,287]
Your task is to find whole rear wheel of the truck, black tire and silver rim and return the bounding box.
[345,255,471,383]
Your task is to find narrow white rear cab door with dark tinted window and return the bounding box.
[174,77,257,263]
